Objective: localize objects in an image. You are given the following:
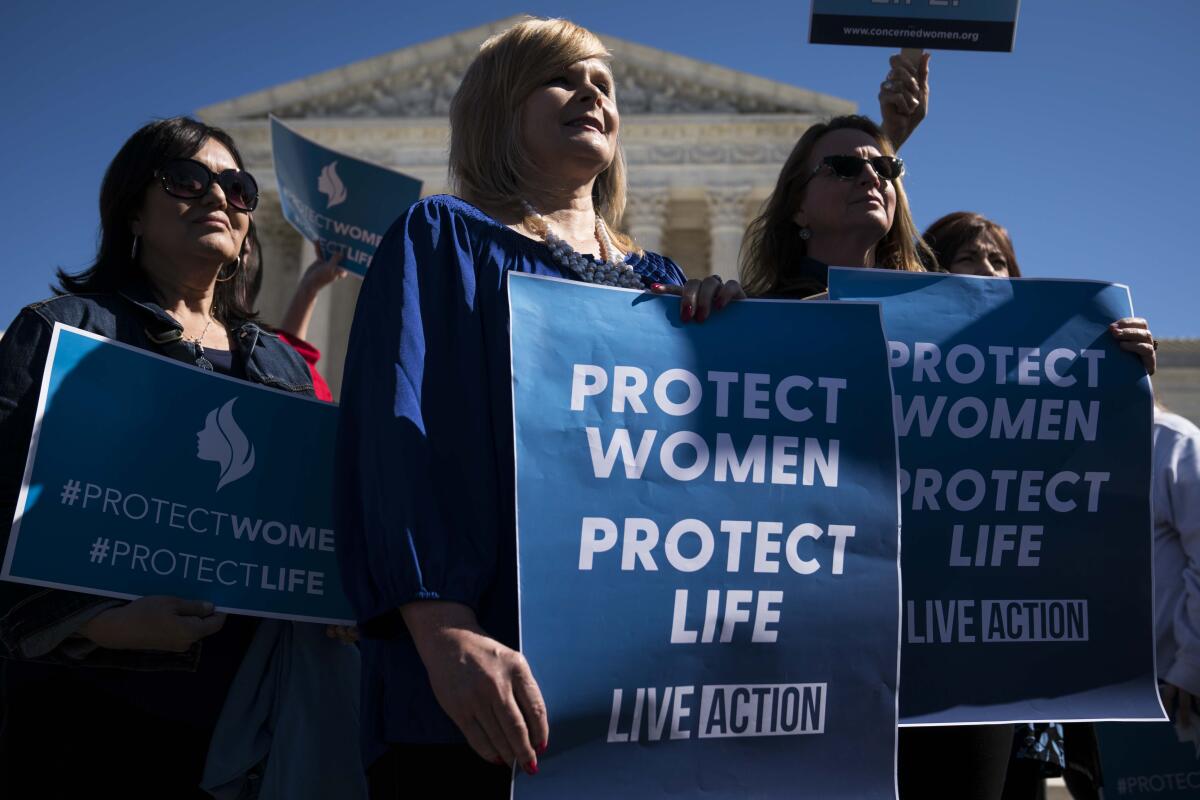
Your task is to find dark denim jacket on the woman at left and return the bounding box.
[0,284,313,669]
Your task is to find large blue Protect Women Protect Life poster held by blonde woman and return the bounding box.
[509,275,899,799]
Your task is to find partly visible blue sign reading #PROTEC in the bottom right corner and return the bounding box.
[1096,722,1200,800]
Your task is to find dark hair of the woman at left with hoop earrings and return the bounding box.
[53,116,257,324]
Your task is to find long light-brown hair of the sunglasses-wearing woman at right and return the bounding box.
[742,114,932,297]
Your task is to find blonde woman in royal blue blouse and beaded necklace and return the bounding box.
[338,19,740,798]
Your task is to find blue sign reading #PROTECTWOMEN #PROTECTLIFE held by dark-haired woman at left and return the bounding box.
[0,324,354,622]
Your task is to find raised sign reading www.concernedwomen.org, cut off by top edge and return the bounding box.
[809,0,1020,52]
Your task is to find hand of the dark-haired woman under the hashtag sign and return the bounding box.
[79,595,226,652]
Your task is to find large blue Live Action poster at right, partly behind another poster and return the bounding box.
[829,269,1162,723]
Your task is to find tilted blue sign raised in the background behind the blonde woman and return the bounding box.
[271,116,421,276]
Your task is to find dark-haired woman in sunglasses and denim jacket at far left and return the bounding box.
[0,118,354,798]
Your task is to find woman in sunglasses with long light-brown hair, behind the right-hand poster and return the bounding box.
[742,115,1154,800]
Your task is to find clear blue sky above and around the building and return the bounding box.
[0,0,1200,336]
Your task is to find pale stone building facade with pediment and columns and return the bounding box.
[198,17,1200,423]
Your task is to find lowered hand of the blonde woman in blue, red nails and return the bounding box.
[400,601,550,775]
